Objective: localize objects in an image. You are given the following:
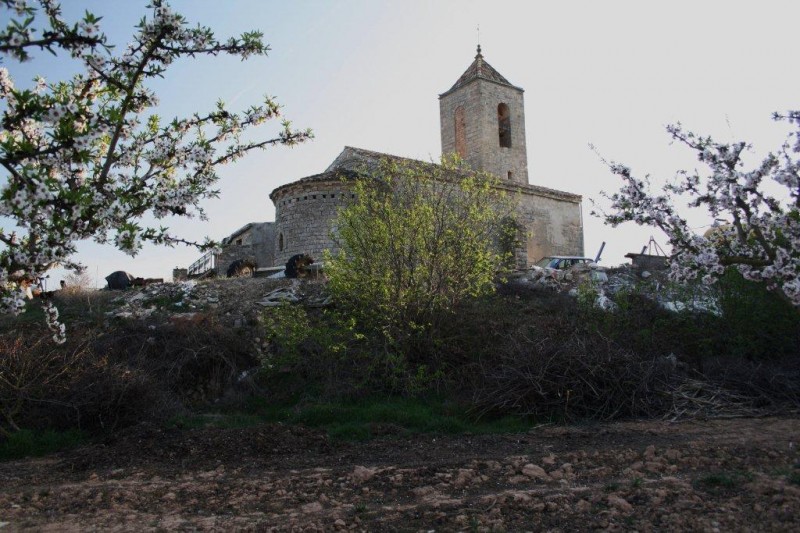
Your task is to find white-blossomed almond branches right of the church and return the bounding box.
[602,111,800,307]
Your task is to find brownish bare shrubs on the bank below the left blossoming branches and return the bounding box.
[0,319,255,432]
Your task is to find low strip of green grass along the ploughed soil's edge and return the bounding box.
[170,398,531,441]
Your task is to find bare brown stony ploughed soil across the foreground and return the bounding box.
[0,415,800,531]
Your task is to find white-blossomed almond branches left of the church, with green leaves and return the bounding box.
[0,0,311,341]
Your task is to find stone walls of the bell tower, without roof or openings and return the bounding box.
[439,79,528,185]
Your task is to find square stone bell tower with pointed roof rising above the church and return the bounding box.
[439,45,528,185]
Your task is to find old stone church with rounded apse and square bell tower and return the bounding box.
[190,46,583,274]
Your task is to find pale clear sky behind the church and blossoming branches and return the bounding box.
[4,0,800,286]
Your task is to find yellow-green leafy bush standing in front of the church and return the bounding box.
[326,154,509,336]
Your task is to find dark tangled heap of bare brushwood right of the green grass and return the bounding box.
[471,329,673,421]
